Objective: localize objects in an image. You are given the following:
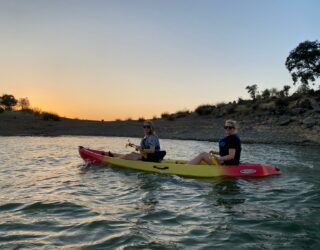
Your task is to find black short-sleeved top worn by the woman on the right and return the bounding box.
[219,134,241,165]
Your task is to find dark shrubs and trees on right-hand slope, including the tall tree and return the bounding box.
[161,41,320,121]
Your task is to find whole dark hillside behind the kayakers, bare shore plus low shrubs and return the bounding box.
[0,91,320,145]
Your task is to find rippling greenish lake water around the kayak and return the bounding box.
[0,137,320,249]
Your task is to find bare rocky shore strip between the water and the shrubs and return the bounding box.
[0,110,320,145]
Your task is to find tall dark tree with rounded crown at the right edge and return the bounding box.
[286,40,320,86]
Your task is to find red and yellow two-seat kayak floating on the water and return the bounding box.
[79,147,281,178]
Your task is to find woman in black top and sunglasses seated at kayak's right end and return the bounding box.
[186,120,241,165]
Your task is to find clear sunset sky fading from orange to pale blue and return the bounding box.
[0,0,320,120]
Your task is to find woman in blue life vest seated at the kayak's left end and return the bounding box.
[109,120,166,162]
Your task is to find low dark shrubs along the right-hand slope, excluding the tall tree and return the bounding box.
[161,88,320,121]
